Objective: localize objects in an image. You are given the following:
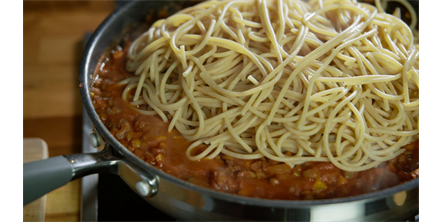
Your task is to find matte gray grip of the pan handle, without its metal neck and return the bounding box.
[23,156,73,206]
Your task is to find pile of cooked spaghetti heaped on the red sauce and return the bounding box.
[120,0,419,171]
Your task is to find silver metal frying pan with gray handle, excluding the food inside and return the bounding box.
[23,0,419,221]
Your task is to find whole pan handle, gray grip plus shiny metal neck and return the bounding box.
[23,151,122,206]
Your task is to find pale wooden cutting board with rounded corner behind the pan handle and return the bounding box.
[23,138,48,222]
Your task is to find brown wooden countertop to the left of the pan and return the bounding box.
[23,0,115,221]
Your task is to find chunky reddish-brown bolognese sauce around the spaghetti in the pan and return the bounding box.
[91,43,419,200]
